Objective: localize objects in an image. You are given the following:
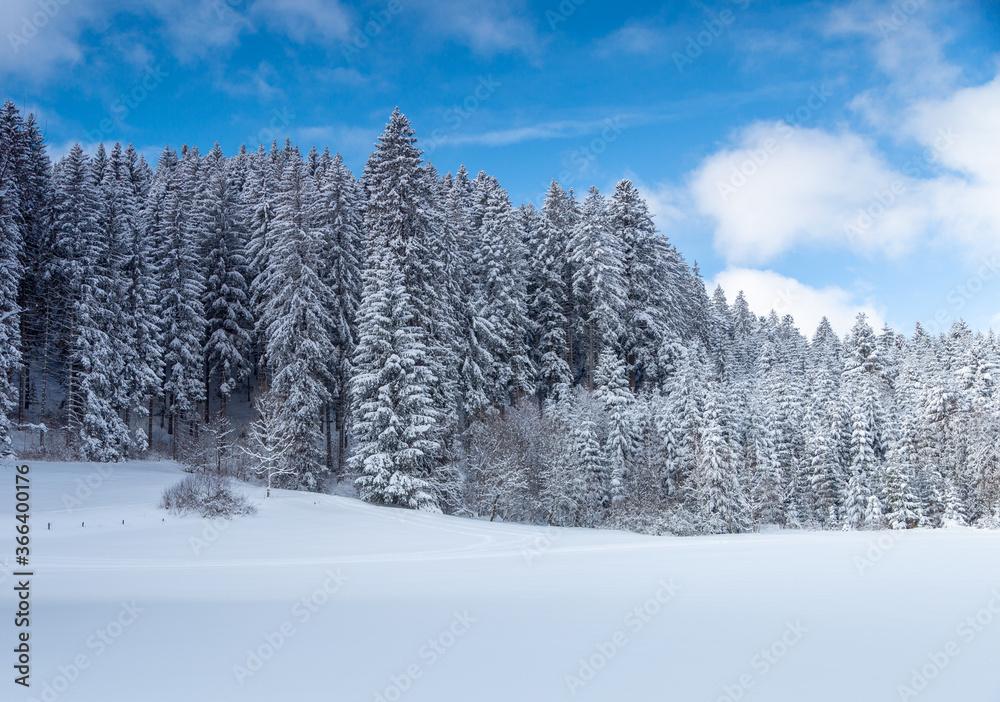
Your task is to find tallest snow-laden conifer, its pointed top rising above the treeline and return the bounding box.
[351,109,449,510]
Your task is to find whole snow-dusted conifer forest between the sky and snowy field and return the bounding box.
[0,103,1000,534]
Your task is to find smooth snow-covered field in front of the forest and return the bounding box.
[0,463,1000,702]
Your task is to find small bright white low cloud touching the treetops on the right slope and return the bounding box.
[707,268,885,337]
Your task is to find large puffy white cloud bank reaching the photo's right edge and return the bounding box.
[690,71,1000,264]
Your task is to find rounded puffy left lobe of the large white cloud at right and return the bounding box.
[690,122,915,263]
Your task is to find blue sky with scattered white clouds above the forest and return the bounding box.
[0,0,1000,334]
